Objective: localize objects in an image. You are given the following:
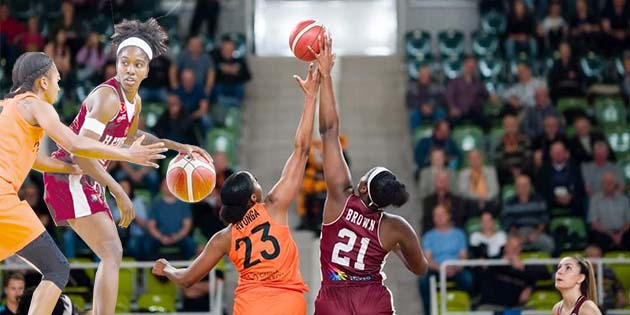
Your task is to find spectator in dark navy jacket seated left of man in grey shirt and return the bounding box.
[536,141,585,216]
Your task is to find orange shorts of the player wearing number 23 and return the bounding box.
[233,288,306,315]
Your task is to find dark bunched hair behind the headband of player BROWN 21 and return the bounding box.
[369,171,409,208]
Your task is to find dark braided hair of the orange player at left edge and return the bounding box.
[5,52,54,98]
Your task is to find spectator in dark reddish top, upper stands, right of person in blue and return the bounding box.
[446,56,496,129]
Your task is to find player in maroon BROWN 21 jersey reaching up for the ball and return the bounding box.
[311,36,428,315]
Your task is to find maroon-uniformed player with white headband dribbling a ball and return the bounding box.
[44,18,212,315]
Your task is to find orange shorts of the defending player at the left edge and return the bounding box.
[0,189,46,261]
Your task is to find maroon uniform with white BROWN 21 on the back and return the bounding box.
[315,194,394,315]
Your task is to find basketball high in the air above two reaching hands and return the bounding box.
[289,20,326,62]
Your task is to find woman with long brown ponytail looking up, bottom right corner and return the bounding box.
[551,256,602,315]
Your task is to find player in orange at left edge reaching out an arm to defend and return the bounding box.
[0,52,166,315]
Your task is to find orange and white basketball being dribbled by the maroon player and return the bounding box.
[166,153,217,202]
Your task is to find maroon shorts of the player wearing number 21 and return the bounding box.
[315,283,395,315]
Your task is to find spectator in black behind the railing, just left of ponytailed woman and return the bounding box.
[478,235,536,311]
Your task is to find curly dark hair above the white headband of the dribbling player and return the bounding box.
[112,18,168,58]
